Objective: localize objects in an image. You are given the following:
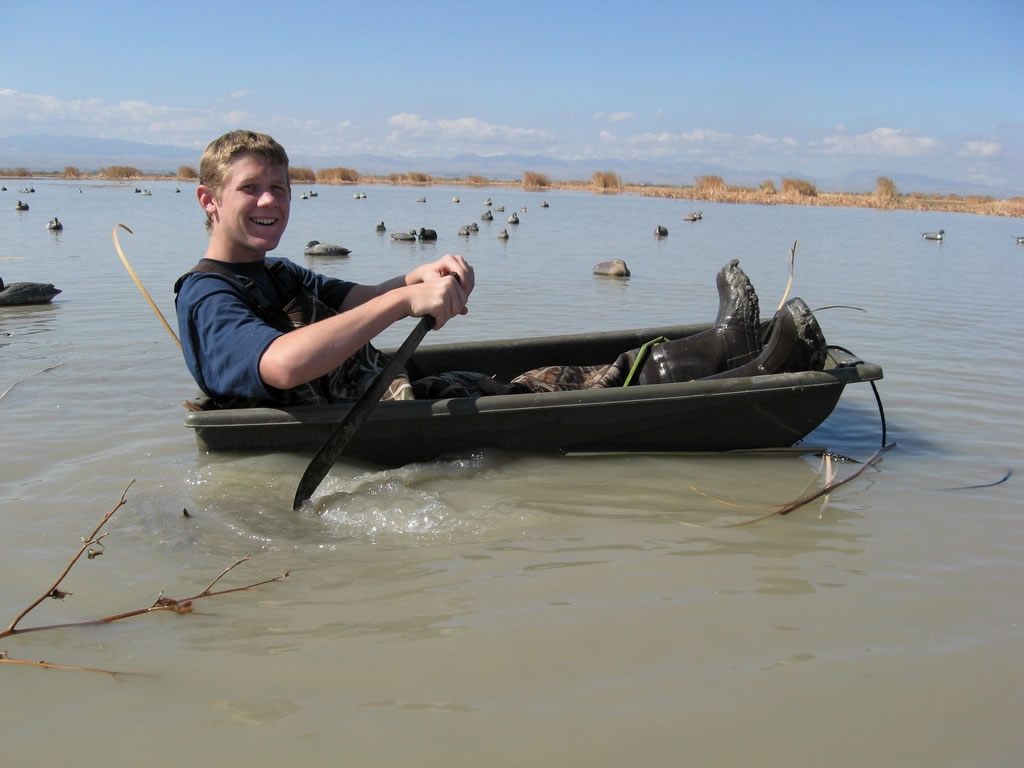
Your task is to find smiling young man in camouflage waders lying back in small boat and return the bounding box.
[174,130,825,408]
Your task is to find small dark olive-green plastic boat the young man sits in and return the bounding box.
[184,325,882,466]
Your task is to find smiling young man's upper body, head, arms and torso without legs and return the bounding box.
[175,130,474,406]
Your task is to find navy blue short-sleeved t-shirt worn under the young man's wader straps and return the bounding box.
[174,258,355,400]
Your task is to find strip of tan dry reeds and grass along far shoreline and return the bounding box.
[0,166,1024,218]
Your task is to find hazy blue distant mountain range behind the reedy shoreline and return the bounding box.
[0,136,1016,197]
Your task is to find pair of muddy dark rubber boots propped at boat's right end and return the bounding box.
[627,259,827,384]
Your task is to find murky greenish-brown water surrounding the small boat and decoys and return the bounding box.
[0,180,1024,766]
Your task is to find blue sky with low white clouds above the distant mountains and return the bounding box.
[6,0,1024,195]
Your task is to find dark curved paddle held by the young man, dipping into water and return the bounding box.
[292,314,434,509]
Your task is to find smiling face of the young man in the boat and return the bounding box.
[200,153,292,261]
